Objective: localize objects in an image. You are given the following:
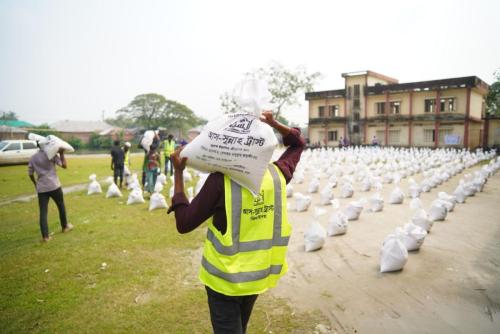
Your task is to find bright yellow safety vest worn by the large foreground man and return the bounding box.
[199,164,292,296]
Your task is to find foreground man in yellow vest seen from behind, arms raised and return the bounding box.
[168,111,305,334]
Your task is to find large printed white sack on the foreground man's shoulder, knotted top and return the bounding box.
[181,79,278,194]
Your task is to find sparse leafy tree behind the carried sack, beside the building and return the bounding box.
[220,62,321,118]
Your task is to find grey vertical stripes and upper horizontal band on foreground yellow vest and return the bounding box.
[207,166,290,255]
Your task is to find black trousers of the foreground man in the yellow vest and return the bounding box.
[205,286,258,334]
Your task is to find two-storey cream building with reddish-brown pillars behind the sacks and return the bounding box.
[306,71,488,148]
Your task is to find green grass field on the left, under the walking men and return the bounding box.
[0,158,321,333]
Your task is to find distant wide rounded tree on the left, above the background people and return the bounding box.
[115,93,205,132]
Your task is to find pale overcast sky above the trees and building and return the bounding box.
[0,0,500,124]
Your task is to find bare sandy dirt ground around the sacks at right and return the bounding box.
[272,166,500,333]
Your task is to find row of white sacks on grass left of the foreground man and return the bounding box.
[87,170,208,211]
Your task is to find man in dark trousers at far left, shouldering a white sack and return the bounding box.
[28,143,73,241]
